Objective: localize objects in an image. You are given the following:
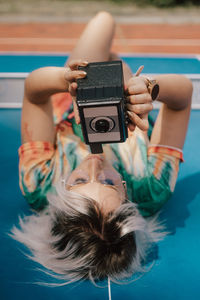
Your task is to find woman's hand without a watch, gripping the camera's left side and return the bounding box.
[65,59,88,124]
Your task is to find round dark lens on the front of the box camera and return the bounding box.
[90,117,115,133]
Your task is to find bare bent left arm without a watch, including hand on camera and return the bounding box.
[21,60,87,143]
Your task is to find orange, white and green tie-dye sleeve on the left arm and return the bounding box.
[18,141,55,210]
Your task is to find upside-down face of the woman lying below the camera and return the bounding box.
[65,154,125,213]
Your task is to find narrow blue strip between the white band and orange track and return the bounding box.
[0,54,200,74]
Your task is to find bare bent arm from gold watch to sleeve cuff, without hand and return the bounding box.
[150,75,193,149]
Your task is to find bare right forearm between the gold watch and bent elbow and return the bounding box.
[154,74,193,110]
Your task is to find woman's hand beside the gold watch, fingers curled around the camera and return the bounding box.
[126,75,153,131]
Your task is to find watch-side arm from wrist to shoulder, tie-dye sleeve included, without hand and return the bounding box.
[130,75,192,217]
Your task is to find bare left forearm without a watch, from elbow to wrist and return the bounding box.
[25,67,69,104]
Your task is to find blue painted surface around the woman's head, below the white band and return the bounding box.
[0,54,200,300]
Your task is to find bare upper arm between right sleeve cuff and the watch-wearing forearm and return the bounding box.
[150,102,191,149]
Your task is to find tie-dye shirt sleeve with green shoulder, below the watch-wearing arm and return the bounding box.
[134,146,183,217]
